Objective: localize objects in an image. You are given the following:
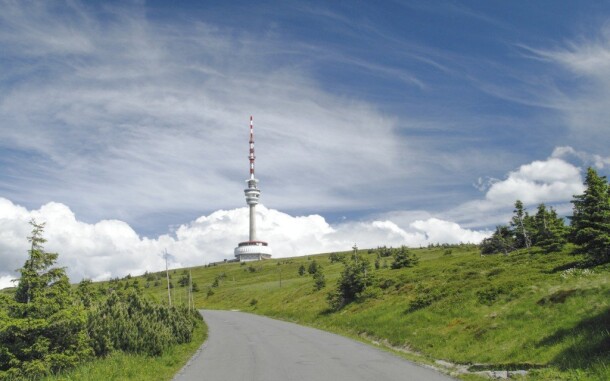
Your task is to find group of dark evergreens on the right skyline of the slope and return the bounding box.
[480,168,610,265]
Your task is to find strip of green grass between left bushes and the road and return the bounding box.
[43,314,207,381]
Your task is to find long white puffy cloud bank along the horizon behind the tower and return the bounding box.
[0,198,489,287]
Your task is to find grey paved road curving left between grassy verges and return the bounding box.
[174,310,451,381]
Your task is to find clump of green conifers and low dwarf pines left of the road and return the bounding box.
[0,220,201,380]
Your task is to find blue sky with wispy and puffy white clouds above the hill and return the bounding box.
[0,0,610,288]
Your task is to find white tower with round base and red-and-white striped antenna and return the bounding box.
[234,117,271,262]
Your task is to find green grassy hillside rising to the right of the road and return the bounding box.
[140,247,610,380]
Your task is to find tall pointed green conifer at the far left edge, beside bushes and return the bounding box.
[0,220,93,379]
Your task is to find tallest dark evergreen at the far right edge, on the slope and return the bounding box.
[569,168,610,263]
